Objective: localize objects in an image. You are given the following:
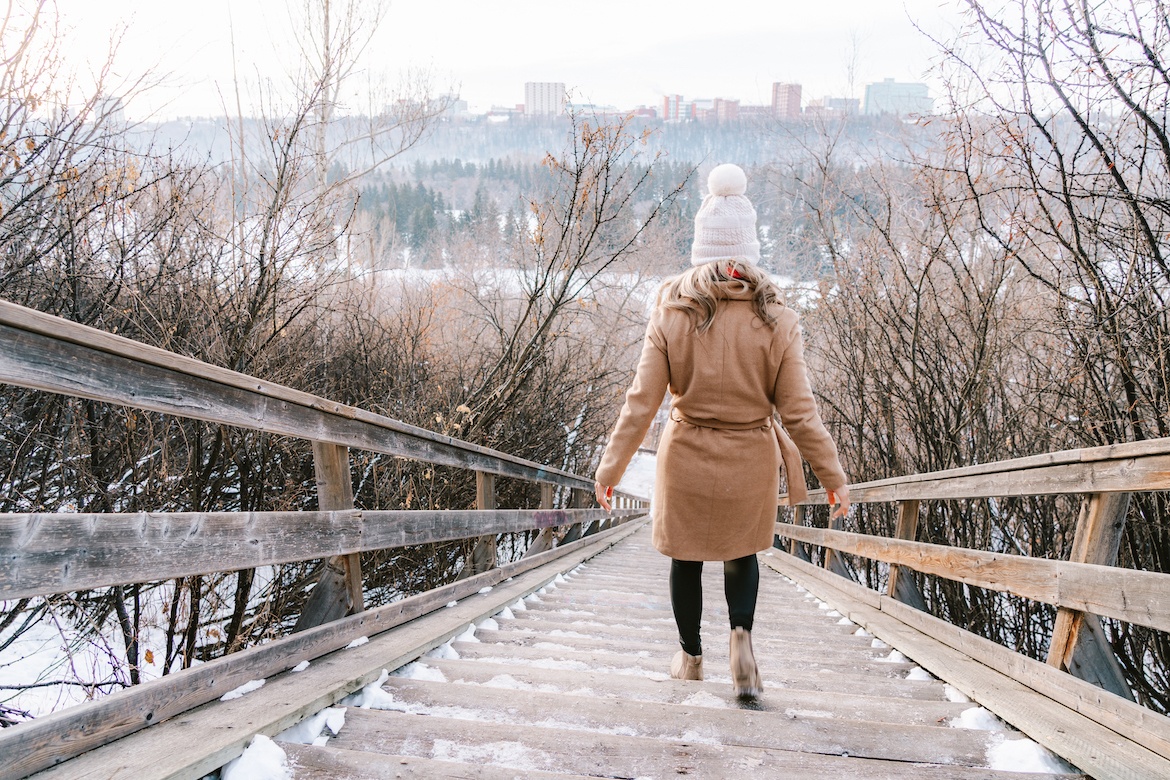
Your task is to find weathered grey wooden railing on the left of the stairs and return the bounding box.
[0,302,647,778]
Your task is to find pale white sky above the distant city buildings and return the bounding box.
[57,0,962,118]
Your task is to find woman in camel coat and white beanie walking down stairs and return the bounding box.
[594,165,849,697]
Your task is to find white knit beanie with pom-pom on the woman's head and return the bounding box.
[690,164,759,265]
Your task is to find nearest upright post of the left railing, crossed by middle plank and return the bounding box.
[293,441,365,631]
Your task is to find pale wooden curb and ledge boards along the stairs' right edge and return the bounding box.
[763,554,1170,780]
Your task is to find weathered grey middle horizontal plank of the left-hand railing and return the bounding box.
[0,509,645,600]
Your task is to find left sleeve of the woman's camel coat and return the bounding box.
[596,309,670,485]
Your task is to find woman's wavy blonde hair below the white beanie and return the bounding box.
[658,260,784,333]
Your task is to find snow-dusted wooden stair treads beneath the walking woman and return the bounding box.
[273,527,1081,780]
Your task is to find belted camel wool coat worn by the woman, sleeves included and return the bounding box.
[597,282,846,560]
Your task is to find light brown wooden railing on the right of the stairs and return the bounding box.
[776,439,1170,776]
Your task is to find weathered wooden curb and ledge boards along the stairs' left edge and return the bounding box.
[11,523,642,780]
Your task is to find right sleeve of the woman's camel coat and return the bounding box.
[772,315,848,490]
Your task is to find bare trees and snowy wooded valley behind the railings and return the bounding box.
[0,0,1170,724]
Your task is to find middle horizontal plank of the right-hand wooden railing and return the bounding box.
[776,523,1170,631]
